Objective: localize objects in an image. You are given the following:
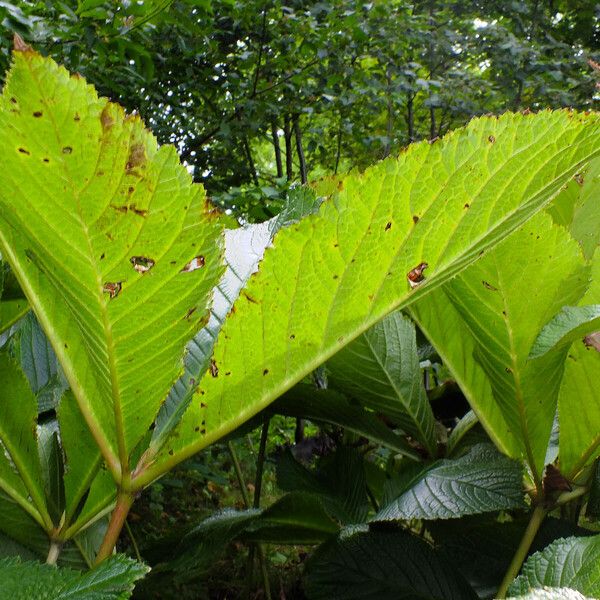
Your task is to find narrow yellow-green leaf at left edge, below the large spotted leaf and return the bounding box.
[0,352,52,528]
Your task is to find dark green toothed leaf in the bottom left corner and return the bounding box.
[0,555,149,600]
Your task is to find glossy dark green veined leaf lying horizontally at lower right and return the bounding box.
[374,444,525,521]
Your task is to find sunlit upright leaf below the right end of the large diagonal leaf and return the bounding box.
[413,214,589,480]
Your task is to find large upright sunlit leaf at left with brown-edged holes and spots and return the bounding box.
[0,51,222,466]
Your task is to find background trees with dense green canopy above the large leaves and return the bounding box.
[0,0,600,220]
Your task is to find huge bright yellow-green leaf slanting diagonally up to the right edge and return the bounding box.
[138,112,600,485]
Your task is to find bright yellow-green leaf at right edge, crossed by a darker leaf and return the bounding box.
[556,255,600,478]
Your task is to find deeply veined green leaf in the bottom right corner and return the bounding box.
[509,535,600,598]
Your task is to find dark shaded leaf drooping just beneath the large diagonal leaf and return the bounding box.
[272,383,420,460]
